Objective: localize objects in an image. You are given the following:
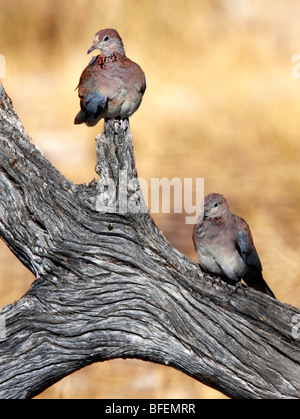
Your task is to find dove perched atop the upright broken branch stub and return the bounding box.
[74,29,146,127]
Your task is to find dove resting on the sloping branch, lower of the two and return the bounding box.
[193,193,275,298]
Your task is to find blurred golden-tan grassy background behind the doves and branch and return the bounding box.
[0,0,300,398]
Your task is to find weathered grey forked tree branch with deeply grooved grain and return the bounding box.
[0,85,300,398]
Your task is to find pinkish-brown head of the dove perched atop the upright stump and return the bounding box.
[87,29,125,57]
